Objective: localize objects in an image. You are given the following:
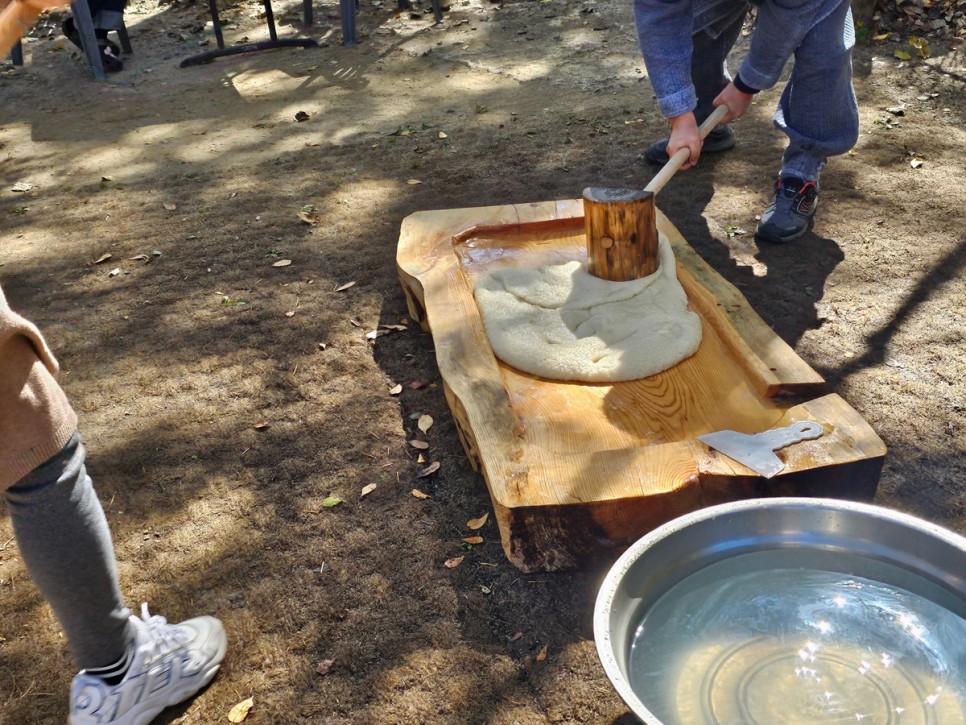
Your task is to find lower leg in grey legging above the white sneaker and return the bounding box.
[5,433,131,669]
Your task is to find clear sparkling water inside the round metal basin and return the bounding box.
[629,550,966,725]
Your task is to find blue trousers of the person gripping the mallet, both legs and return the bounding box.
[691,3,859,181]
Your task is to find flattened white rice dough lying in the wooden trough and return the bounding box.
[474,236,701,383]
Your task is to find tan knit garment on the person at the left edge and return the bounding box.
[0,282,77,491]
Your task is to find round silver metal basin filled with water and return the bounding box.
[594,498,966,725]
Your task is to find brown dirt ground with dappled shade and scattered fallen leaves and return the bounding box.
[0,0,966,725]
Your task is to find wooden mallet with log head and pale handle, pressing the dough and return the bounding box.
[584,106,728,282]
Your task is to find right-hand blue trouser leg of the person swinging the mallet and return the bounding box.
[775,2,859,181]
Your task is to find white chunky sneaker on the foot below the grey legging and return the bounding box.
[67,604,228,725]
